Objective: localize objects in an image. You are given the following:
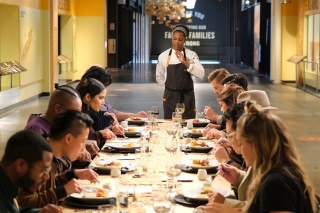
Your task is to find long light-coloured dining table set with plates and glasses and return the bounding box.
[62,119,233,213]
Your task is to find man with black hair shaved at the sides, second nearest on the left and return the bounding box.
[19,110,98,207]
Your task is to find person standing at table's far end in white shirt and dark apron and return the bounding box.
[156,25,204,119]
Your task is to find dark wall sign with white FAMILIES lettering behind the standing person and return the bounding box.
[151,0,229,59]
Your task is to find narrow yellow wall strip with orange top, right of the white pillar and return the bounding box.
[279,1,298,81]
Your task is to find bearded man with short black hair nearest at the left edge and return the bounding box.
[0,130,62,213]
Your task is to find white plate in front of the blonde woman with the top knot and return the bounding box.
[183,186,230,200]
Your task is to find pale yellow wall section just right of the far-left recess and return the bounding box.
[20,6,49,100]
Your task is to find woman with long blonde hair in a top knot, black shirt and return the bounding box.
[204,102,316,213]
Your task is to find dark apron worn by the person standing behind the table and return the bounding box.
[163,49,196,119]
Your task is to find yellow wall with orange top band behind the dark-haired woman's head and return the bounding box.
[71,0,106,80]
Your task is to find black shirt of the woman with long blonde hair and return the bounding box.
[248,169,312,213]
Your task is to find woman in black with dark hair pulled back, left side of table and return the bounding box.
[77,78,115,148]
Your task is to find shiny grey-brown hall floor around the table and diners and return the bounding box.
[0,62,320,194]
